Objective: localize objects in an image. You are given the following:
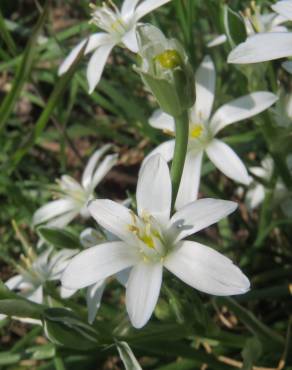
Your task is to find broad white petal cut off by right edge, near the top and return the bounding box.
[227,32,292,64]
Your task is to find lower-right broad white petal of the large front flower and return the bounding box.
[164,241,250,296]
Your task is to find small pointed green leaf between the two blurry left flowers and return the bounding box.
[38,226,81,249]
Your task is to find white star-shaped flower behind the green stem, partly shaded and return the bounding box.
[149,56,277,209]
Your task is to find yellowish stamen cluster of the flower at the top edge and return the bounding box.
[90,0,128,37]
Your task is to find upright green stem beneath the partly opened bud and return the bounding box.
[170,111,189,209]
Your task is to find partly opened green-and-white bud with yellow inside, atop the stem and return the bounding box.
[135,24,195,117]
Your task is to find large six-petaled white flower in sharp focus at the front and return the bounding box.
[62,155,250,328]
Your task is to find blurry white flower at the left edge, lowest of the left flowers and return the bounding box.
[5,248,76,303]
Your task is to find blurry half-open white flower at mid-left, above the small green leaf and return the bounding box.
[33,145,118,227]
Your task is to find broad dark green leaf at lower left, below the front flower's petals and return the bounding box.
[43,308,98,351]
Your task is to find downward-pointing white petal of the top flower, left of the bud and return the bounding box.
[86,42,115,94]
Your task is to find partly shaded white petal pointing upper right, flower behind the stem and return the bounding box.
[211,91,278,135]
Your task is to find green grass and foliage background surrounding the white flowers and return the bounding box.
[0,0,292,370]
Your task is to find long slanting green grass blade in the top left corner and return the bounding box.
[0,1,50,132]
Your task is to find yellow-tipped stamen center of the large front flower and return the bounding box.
[129,212,167,261]
